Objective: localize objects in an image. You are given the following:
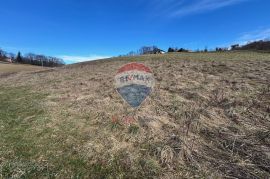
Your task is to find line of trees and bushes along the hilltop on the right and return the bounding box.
[121,40,270,56]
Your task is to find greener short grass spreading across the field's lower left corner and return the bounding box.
[0,87,156,178]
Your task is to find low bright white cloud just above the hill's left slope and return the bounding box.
[58,55,111,64]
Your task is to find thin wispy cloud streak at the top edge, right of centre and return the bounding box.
[154,0,250,17]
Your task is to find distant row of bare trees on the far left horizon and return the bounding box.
[0,49,65,67]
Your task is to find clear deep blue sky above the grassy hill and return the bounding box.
[0,0,270,63]
